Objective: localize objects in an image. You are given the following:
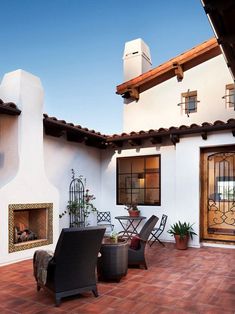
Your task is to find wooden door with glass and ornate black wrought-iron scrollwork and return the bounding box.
[201,146,235,242]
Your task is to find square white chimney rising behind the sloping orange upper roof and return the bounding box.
[123,38,152,81]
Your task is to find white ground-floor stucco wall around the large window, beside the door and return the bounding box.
[101,132,235,247]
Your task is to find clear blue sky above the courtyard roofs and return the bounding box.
[0,0,213,134]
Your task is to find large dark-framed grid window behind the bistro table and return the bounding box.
[117,155,161,205]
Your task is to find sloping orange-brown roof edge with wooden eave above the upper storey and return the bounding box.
[116,38,221,95]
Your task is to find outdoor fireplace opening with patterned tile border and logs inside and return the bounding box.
[9,203,53,253]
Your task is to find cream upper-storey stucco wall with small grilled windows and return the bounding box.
[123,55,235,133]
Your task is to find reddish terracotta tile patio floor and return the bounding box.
[0,244,235,314]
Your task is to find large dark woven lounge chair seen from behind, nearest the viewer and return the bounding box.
[34,227,105,306]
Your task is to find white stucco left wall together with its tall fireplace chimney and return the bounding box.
[0,70,101,265]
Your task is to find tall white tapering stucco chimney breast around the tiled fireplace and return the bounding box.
[0,70,59,264]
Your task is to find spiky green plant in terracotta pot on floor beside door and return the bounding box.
[167,221,197,250]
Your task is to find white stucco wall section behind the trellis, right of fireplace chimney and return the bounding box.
[44,135,101,230]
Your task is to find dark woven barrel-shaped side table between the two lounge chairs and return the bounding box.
[97,237,128,282]
